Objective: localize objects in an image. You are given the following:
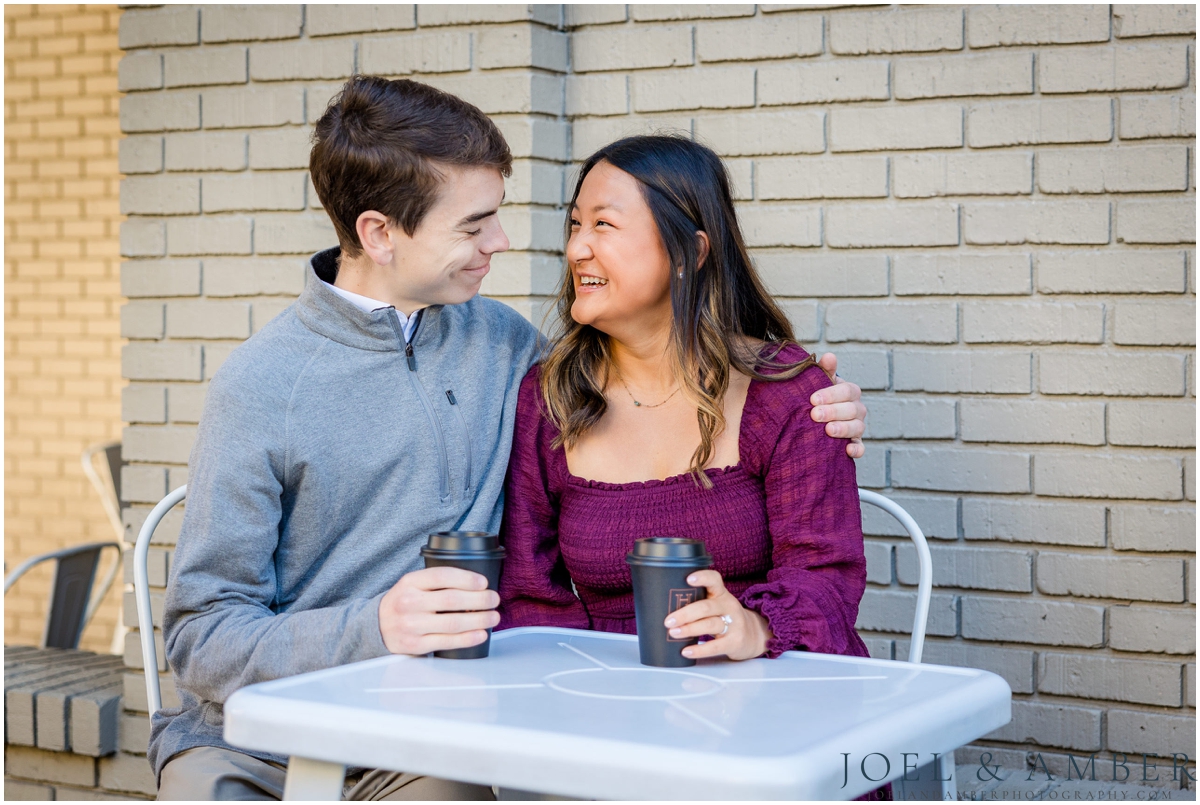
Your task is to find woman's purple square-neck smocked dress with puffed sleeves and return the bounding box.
[499,347,866,656]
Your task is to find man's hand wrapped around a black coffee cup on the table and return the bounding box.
[379,567,500,654]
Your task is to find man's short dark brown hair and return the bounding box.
[308,76,512,257]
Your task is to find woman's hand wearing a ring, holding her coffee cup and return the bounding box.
[664,570,773,660]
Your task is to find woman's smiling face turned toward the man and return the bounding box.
[566,162,671,335]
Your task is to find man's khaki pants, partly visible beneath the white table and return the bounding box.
[158,746,496,801]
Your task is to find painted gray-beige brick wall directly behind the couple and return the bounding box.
[121,5,1195,774]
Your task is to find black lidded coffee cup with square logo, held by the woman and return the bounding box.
[625,536,713,668]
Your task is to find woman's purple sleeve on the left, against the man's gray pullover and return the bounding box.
[497,366,590,629]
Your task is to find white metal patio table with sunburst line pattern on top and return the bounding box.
[224,627,1012,799]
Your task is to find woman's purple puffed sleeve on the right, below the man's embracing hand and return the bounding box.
[740,367,868,657]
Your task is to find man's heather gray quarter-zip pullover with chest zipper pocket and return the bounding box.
[149,248,538,774]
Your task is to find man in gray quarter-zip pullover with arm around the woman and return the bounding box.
[149,77,865,799]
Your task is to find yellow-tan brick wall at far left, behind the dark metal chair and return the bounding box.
[5,5,122,651]
